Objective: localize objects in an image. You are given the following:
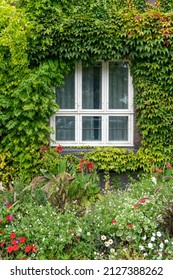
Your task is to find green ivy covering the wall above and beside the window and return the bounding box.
[0,0,173,182]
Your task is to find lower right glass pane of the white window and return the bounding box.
[109,116,128,141]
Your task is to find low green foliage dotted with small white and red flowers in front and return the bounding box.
[0,164,173,260]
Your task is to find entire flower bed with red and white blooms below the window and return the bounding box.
[0,159,173,260]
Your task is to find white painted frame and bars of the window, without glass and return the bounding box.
[50,61,134,147]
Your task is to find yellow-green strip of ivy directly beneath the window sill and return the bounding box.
[85,143,173,174]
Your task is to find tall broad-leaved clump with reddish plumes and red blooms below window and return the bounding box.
[20,155,101,213]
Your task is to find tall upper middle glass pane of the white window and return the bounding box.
[82,62,102,109]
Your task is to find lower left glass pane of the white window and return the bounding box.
[56,116,75,141]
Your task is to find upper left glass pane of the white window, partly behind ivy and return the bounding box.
[56,73,75,109]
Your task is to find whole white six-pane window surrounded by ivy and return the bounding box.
[51,61,133,146]
